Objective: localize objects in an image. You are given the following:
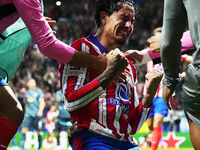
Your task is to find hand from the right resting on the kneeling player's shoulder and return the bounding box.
[124,50,143,65]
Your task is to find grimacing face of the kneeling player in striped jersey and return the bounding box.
[104,4,135,45]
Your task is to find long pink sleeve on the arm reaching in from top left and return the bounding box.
[13,0,75,63]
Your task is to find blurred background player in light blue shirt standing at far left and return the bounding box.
[21,78,45,150]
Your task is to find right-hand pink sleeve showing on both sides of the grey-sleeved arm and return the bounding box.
[146,30,195,59]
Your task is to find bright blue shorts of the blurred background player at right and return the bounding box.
[148,97,168,118]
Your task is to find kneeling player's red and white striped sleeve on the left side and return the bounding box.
[60,40,105,112]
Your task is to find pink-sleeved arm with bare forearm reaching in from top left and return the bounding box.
[14,0,106,73]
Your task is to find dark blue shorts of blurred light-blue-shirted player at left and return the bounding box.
[21,116,42,131]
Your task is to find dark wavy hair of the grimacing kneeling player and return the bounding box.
[94,0,139,28]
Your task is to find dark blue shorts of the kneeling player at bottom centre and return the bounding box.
[72,130,140,150]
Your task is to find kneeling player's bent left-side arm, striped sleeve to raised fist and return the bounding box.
[63,50,128,112]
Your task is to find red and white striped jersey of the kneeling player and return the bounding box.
[60,34,150,143]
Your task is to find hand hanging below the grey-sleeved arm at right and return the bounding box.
[163,85,175,110]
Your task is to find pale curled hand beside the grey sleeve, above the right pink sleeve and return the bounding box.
[147,36,160,53]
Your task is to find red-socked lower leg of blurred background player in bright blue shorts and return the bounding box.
[151,114,164,150]
